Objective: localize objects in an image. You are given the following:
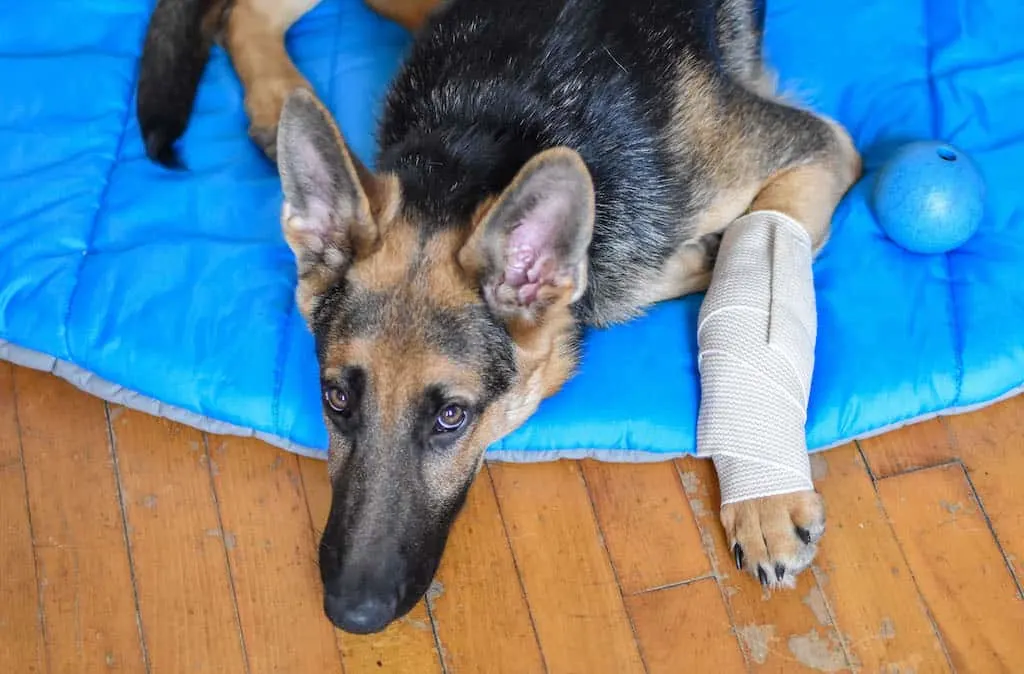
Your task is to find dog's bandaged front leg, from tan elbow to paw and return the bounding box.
[697,116,860,588]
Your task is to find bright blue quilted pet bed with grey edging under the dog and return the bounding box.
[0,0,1024,460]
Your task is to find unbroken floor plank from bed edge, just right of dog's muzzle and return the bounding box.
[488,461,644,674]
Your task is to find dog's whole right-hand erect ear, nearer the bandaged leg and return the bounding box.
[459,148,594,322]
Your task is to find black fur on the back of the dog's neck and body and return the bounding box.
[379,0,759,324]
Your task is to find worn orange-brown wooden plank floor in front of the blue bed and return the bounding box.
[0,364,1024,674]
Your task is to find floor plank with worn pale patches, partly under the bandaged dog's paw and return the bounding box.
[676,458,851,673]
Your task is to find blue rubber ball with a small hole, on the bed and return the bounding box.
[872,141,985,255]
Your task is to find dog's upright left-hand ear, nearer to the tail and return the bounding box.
[278,88,383,280]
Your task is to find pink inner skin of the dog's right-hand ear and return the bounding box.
[505,194,569,304]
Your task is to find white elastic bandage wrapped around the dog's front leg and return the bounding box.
[697,211,817,505]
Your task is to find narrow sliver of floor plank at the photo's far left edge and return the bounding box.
[0,363,46,674]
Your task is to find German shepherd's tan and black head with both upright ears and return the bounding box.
[278,90,594,633]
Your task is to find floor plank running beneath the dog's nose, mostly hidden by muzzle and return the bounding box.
[299,458,441,674]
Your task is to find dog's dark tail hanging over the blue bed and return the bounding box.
[136,0,232,168]
